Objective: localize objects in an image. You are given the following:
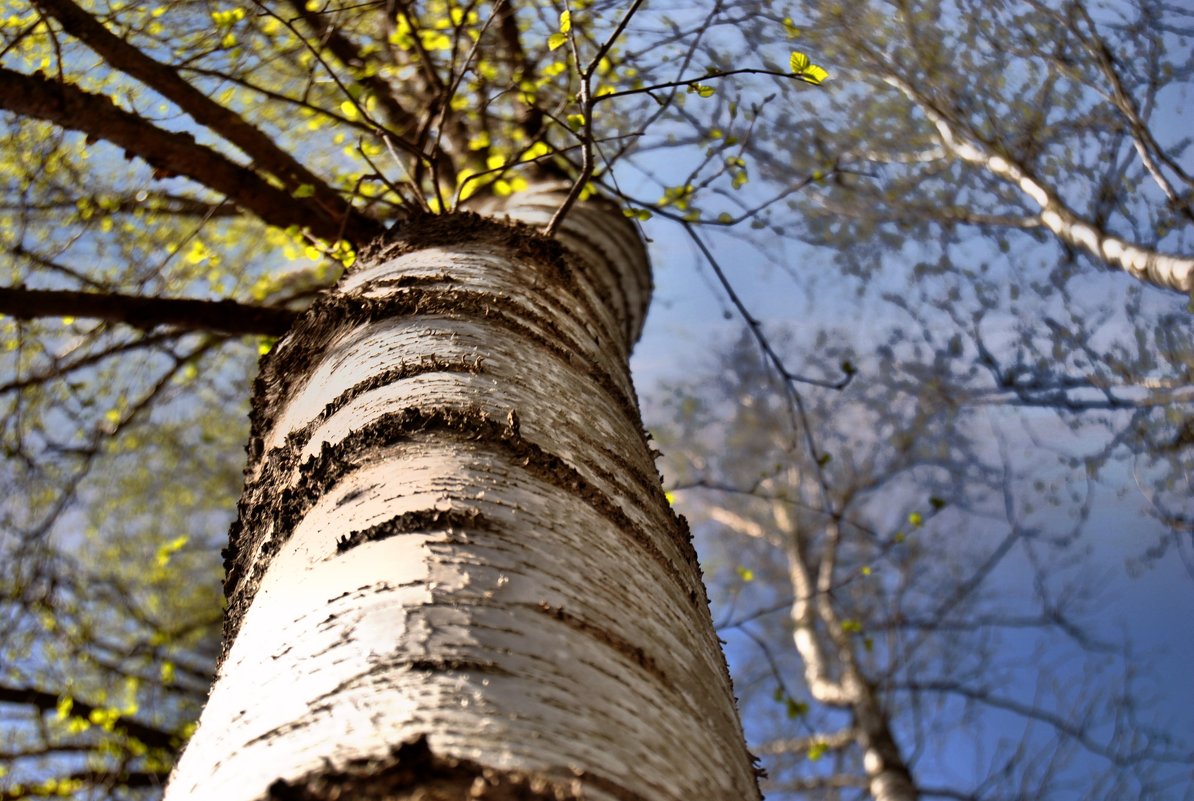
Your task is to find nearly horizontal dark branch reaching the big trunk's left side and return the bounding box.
[0,286,299,337]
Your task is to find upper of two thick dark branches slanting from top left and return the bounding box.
[35,0,367,241]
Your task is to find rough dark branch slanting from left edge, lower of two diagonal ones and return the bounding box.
[0,67,383,247]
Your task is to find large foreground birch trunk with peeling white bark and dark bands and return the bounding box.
[166,187,759,801]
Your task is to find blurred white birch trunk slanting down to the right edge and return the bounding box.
[884,75,1194,294]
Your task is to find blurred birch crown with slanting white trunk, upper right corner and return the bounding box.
[725,0,1194,295]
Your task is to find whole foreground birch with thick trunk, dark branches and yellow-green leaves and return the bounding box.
[0,0,817,799]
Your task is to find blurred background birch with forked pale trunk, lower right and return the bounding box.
[657,331,1190,799]
